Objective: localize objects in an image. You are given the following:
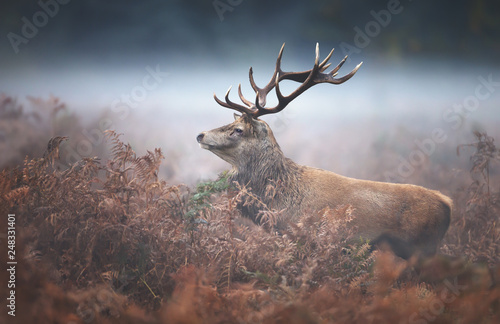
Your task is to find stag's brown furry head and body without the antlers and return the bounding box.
[197,114,452,258]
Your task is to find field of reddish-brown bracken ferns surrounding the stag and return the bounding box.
[0,96,500,323]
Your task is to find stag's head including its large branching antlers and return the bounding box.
[197,44,362,169]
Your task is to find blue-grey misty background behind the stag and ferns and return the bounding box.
[0,0,500,184]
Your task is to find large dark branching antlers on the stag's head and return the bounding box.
[214,43,363,118]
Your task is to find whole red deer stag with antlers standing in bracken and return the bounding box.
[196,44,453,259]
